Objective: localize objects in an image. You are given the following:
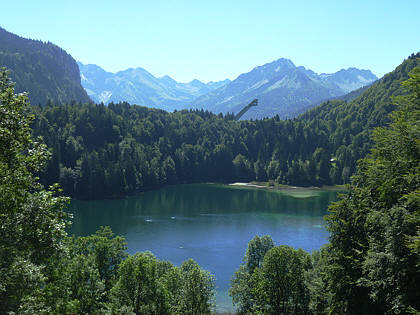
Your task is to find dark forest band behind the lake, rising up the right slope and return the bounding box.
[32,54,419,199]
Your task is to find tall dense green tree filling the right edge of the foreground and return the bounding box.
[327,63,420,314]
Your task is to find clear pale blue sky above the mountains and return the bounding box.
[0,0,420,82]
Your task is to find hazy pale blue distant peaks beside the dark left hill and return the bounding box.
[78,62,230,111]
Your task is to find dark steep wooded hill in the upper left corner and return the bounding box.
[0,28,90,105]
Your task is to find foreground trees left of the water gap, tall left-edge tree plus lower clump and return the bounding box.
[0,71,214,315]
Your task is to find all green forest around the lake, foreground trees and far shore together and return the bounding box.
[0,55,420,315]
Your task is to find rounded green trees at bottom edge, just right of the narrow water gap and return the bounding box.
[229,235,312,314]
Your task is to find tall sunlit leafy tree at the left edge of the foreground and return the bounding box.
[0,70,67,313]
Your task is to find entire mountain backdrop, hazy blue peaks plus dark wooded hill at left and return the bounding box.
[0,28,377,119]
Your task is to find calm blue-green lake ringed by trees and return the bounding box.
[69,184,337,311]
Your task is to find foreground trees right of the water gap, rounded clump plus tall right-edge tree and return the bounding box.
[229,63,420,315]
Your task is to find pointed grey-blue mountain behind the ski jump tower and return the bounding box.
[191,58,378,119]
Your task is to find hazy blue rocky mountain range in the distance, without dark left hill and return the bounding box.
[78,58,378,119]
